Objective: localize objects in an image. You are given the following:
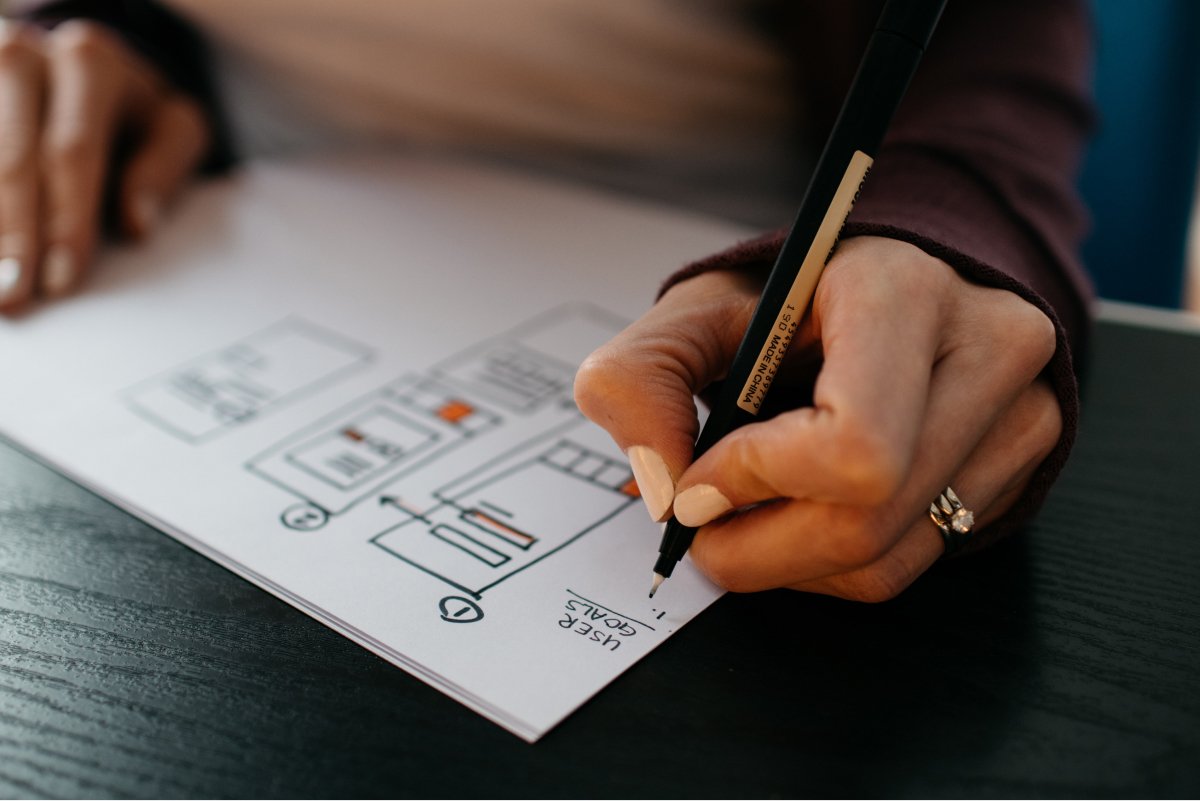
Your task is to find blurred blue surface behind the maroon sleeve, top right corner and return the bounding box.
[1081,0,1200,311]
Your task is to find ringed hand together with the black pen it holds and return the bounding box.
[576,0,1062,600]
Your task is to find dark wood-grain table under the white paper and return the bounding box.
[0,311,1200,797]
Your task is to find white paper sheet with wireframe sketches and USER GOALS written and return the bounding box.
[0,153,745,740]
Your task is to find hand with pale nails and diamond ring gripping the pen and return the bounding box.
[575,236,1062,601]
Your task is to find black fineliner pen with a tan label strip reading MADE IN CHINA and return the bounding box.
[650,0,946,597]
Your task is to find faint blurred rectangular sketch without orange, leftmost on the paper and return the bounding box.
[125,318,372,444]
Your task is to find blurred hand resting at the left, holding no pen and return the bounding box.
[0,22,209,312]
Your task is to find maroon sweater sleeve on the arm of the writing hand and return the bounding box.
[664,0,1092,550]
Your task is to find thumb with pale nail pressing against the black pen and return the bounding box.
[575,272,758,520]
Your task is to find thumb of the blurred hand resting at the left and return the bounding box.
[120,96,209,239]
